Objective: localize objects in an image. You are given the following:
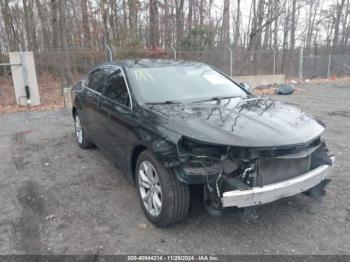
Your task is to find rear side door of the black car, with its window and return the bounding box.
[84,66,109,143]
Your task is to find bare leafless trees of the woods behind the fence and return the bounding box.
[0,0,350,80]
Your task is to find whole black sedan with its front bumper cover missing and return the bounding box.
[72,59,334,227]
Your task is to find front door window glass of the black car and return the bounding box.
[104,69,130,106]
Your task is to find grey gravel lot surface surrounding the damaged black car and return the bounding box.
[0,81,350,254]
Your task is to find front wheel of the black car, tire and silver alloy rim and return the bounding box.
[135,150,190,227]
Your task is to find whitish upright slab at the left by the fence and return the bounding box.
[9,52,40,106]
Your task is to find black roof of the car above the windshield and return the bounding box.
[101,58,203,68]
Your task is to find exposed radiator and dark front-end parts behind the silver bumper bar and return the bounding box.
[177,135,332,211]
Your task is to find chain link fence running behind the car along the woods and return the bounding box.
[0,48,350,108]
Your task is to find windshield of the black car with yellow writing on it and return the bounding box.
[130,64,247,103]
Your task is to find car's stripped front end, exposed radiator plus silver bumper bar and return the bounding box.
[174,137,334,209]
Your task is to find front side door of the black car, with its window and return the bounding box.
[98,66,136,167]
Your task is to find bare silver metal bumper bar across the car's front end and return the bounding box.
[221,157,335,207]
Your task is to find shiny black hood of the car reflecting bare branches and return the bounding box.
[143,98,324,147]
